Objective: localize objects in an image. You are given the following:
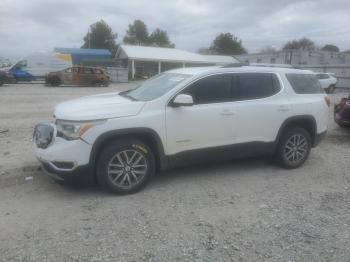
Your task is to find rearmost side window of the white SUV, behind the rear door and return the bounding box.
[286,74,324,94]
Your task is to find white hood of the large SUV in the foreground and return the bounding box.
[55,93,146,121]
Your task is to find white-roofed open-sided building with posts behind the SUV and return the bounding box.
[116,45,238,79]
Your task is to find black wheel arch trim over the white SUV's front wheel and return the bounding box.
[89,128,168,173]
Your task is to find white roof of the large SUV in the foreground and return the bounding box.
[168,66,312,75]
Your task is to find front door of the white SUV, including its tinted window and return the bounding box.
[166,74,236,155]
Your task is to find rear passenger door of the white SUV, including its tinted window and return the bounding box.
[235,73,292,143]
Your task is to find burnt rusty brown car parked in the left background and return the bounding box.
[45,66,109,86]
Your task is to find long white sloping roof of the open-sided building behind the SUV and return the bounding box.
[116,45,237,64]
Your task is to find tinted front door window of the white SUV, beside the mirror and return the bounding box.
[183,74,232,104]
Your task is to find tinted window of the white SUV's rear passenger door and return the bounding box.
[238,73,280,100]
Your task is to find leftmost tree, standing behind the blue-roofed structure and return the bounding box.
[81,20,118,55]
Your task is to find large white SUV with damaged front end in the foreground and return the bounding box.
[33,66,329,194]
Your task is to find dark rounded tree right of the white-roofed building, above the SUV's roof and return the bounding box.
[210,33,247,55]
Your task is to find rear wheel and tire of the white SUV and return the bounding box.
[276,127,312,169]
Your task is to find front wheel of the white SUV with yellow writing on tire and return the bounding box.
[96,139,156,194]
